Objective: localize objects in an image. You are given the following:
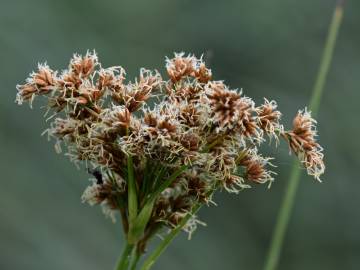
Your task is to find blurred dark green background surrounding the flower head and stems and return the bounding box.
[0,0,360,270]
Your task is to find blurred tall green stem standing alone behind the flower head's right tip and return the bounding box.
[264,0,345,270]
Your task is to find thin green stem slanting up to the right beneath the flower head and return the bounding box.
[141,204,202,270]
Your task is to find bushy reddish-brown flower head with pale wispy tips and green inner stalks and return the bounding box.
[16,53,324,249]
